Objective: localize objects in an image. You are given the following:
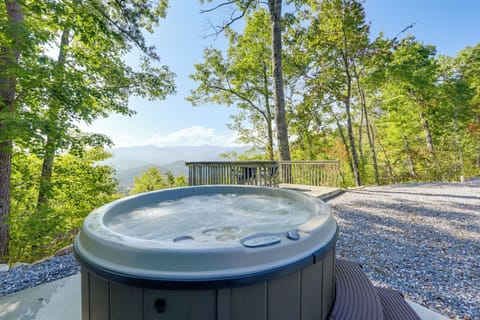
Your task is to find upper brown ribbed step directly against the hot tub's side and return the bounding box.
[329,260,384,320]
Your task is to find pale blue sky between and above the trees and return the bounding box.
[77,0,480,147]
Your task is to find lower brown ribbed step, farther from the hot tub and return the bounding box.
[375,287,421,320]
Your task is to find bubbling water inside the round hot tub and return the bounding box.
[106,194,316,243]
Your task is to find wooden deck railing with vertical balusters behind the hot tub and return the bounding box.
[185,161,340,187]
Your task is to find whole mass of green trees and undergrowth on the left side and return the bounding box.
[0,0,175,261]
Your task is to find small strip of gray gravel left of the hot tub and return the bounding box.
[0,254,80,297]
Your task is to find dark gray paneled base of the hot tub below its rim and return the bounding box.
[82,248,335,320]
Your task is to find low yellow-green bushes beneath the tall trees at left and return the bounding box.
[9,149,119,263]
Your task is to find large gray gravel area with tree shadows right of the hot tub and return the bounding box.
[328,181,480,319]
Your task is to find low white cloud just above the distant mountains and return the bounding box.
[145,126,239,147]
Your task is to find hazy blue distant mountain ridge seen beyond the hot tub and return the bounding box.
[104,146,250,191]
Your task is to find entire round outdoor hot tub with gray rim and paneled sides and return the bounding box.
[74,186,337,320]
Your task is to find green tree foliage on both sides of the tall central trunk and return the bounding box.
[191,0,480,186]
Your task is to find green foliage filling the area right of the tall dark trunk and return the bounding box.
[286,0,480,185]
